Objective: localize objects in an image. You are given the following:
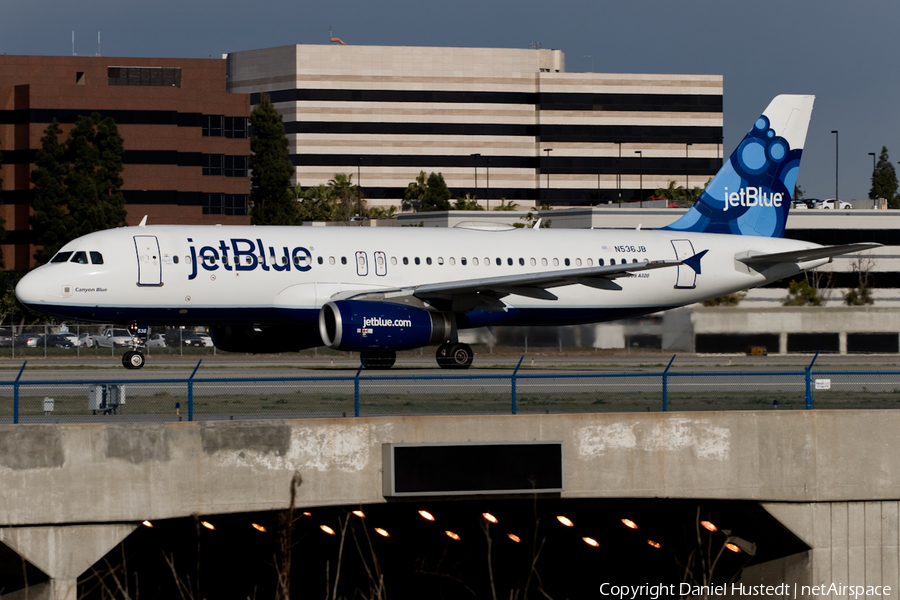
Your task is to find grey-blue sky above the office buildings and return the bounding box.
[0,0,900,200]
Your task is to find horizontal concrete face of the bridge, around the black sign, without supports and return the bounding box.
[0,411,900,526]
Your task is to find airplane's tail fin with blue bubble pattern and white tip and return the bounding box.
[662,95,815,237]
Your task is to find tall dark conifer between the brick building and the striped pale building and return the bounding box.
[250,94,302,225]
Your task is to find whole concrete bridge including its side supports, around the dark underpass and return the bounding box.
[0,410,900,600]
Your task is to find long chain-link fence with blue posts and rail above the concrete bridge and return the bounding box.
[0,354,900,423]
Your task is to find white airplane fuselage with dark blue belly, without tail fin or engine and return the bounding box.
[17,226,828,325]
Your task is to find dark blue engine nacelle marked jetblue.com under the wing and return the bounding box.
[319,300,451,350]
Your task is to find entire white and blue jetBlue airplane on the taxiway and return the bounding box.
[16,95,878,368]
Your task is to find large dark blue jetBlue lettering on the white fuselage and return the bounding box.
[187,238,312,280]
